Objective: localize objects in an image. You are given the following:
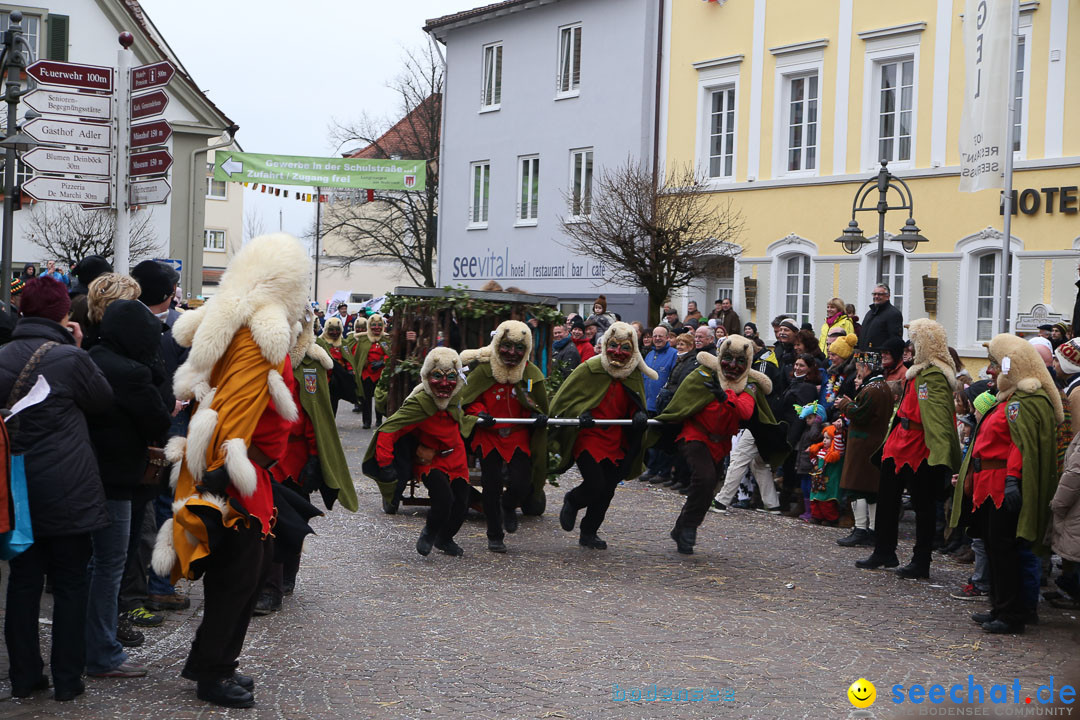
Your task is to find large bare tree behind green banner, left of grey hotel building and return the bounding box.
[321,47,443,287]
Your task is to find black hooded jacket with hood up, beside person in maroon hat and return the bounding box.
[90,300,171,500]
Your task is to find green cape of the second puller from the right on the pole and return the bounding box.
[548,355,645,479]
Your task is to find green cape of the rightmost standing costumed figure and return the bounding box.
[949,388,1057,554]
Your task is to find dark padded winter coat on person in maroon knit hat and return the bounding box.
[0,317,112,538]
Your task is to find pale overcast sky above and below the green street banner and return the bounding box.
[140,0,490,241]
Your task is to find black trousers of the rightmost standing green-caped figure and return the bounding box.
[972,499,1028,625]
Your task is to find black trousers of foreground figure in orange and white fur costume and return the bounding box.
[186,522,273,680]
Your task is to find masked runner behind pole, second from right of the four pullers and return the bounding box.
[549,322,657,549]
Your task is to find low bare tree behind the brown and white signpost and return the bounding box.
[25,203,158,268]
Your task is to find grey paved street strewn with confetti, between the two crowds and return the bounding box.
[0,407,1080,720]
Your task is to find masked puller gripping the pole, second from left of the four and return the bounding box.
[461,320,548,553]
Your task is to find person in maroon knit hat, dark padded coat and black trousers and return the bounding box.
[0,277,112,701]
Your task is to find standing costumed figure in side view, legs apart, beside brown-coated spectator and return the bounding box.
[855,318,960,578]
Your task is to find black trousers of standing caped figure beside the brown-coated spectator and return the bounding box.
[874,460,949,563]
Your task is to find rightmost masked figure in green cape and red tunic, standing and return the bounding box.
[949,334,1065,633]
